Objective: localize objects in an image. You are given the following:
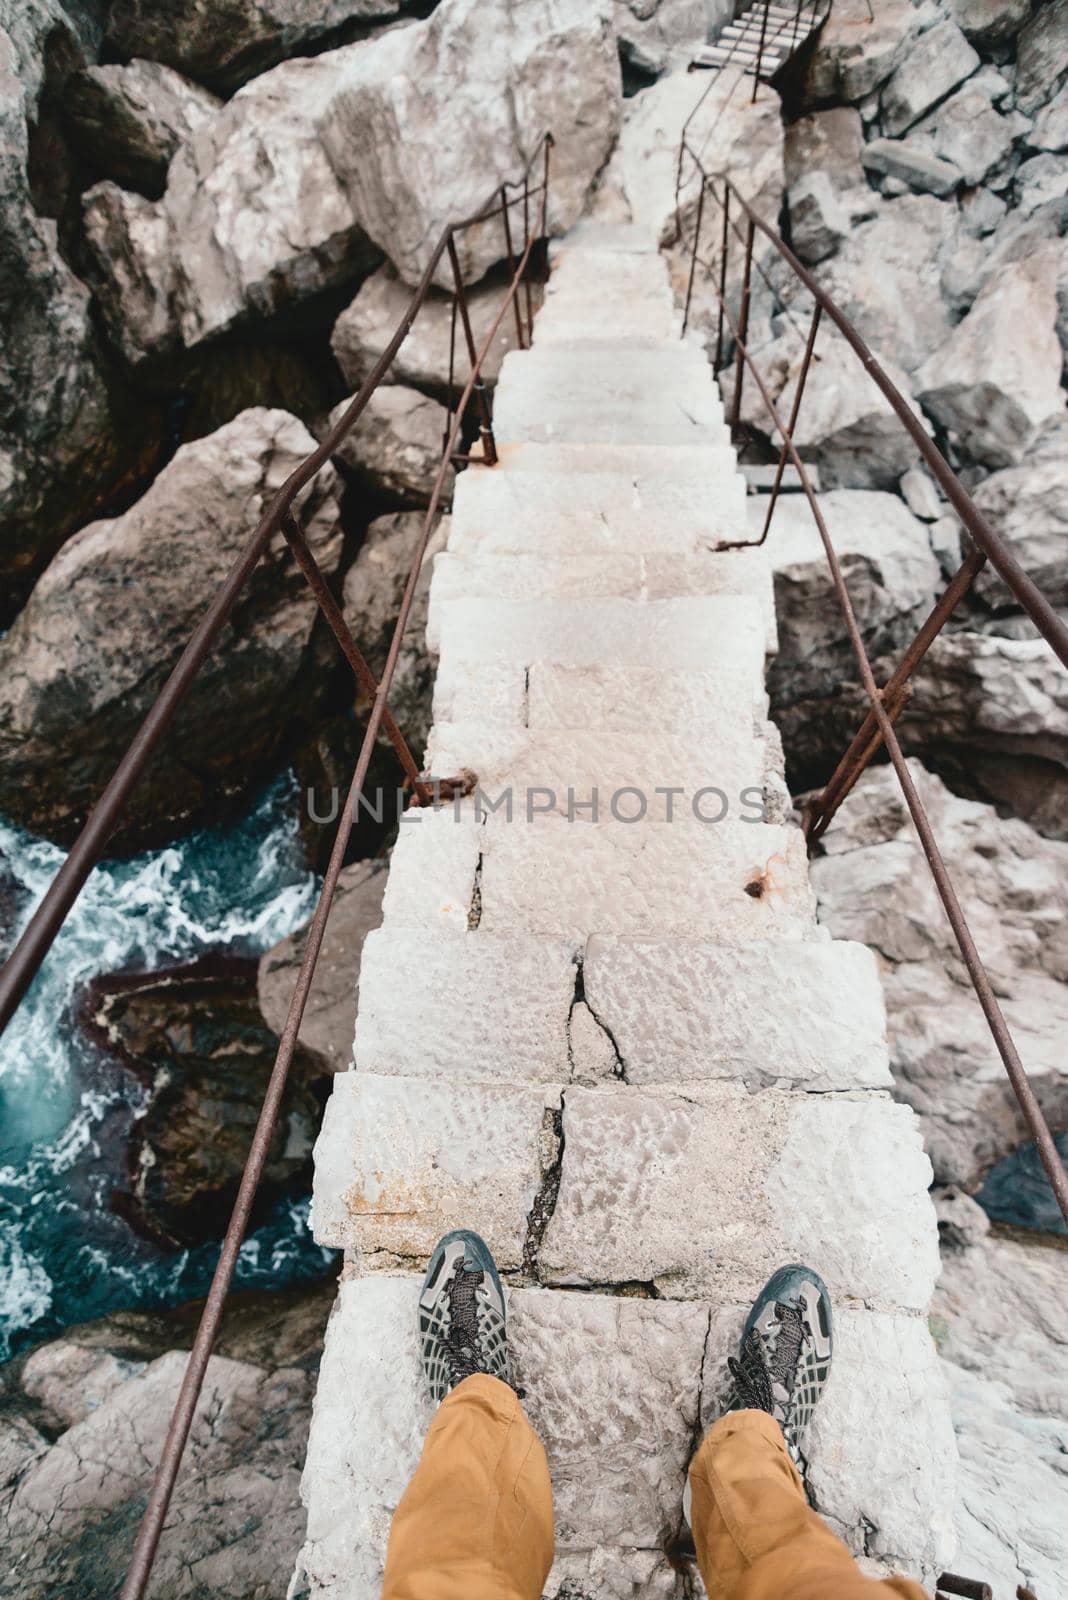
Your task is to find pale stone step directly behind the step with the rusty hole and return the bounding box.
[427,706,770,806]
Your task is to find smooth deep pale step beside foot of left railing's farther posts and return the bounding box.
[494,342,727,446]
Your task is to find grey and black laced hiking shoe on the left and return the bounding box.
[419,1229,512,1403]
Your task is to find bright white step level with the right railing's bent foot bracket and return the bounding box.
[449,464,748,565]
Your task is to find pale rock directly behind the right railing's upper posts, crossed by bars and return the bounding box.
[735,325,916,490]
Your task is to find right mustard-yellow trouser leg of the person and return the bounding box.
[689,1411,926,1600]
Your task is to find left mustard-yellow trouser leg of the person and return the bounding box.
[382,1373,553,1600]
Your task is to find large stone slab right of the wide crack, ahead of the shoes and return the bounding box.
[539,1083,938,1310]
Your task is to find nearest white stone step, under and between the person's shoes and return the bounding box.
[302,1274,953,1600]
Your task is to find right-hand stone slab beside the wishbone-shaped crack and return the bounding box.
[582,936,892,1090]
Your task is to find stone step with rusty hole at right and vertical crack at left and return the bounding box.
[384,819,817,942]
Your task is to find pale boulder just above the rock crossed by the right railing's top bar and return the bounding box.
[815,195,959,373]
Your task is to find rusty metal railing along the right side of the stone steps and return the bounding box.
[676,138,1068,1221]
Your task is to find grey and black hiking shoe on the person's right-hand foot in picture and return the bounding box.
[726,1266,833,1474]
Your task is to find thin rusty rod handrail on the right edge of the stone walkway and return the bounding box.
[674,162,1068,1221]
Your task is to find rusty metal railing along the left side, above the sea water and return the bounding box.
[0,133,553,1600]
